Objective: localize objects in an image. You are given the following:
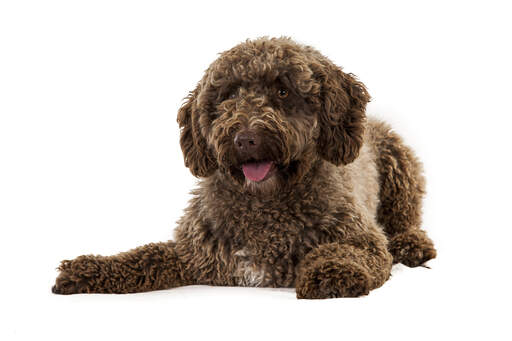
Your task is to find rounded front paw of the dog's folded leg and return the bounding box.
[296,260,371,299]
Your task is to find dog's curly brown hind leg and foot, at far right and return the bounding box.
[374,123,436,267]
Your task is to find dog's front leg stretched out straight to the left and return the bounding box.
[52,242,190,294]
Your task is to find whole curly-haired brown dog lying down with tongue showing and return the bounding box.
[53,38,436,298]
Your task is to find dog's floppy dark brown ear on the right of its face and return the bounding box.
[312,57,370,165]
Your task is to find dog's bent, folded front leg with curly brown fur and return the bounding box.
[296,224,392,299]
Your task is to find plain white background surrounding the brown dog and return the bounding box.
[0,0,512,340]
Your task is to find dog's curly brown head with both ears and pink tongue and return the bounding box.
[178,38,369,194]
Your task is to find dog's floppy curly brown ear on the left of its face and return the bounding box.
[178,86,218,177]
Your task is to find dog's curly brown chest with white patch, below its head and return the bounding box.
[184,181,331,287]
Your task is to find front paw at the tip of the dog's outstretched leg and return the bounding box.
[52,256,100,295]
